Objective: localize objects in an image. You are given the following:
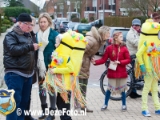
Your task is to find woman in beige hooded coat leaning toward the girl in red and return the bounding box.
[76,26,110,112]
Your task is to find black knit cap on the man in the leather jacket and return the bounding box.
[17,13,32,22]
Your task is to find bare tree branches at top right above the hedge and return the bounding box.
[121,0,160,17]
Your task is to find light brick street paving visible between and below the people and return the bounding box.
[0,26,160,120]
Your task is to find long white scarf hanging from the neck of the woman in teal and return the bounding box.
[37,27,50,78]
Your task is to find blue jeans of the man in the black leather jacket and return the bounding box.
[4,72,32,120]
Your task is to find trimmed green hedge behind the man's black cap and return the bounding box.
[3,7,31,17]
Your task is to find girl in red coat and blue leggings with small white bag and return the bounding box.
[91,32,130,111]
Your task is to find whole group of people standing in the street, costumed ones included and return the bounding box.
[3,13,160,120]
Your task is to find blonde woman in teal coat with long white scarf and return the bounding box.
[37,13,58,120]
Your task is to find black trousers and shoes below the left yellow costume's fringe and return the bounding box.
[57,92,72,120]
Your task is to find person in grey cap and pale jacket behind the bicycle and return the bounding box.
[126,18,141,98]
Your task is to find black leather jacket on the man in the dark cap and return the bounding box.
[3,26,34,74]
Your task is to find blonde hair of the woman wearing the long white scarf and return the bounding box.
[38,12,54,29]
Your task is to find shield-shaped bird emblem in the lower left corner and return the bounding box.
[0,89,16,116]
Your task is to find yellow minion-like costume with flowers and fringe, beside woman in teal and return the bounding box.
[44,31,87,104]
